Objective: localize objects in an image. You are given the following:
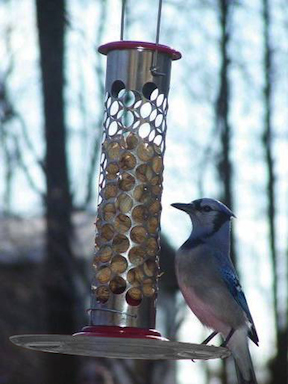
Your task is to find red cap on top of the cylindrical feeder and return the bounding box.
[98,40,182,60]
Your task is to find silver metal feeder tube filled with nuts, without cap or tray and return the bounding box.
[91,43,179,328]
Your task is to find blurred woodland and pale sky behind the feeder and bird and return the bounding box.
[0,0,288,384]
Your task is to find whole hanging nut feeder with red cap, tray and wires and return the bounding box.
[11,1,229,359]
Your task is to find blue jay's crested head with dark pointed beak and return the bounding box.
[172,198,235,236]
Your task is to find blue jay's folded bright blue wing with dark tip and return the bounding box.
[217,255,259,345]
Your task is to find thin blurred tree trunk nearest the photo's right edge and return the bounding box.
[262,0,288,384]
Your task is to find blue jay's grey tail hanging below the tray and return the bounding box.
[228,328,257,384]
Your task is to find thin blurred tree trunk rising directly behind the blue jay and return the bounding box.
[215,0,236,384]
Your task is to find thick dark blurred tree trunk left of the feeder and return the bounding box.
[36,0,76,384]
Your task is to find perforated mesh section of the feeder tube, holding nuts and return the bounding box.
[92,80,168,306]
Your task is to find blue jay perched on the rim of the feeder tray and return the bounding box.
[171,198,259,384]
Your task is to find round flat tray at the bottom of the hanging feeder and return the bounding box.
[10,335,230,360]
